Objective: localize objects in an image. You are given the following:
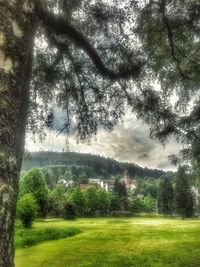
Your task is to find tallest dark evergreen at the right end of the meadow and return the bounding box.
[174,169,195,218]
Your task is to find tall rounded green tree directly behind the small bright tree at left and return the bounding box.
[20,167,49,217]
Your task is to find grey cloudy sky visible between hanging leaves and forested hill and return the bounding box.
[26,112,181,170]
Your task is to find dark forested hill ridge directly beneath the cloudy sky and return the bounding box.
[22,152,164,178]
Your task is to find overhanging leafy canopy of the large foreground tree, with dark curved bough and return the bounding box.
[29,0,200,161]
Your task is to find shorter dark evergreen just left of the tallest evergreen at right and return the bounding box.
[158,177,174,215]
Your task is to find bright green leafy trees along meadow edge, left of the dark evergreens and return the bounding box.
[17,167,158,227]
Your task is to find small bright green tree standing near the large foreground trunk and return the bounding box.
[17,193,38,228]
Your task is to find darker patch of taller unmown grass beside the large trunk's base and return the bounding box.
[15,227,80,249]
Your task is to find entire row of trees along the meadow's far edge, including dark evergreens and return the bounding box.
[17,166,198,227]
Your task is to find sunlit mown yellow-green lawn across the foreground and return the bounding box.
[15,218,200,267]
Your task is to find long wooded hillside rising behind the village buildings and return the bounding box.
[22,152,163,182]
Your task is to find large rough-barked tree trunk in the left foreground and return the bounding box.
[0,0,35,267]
